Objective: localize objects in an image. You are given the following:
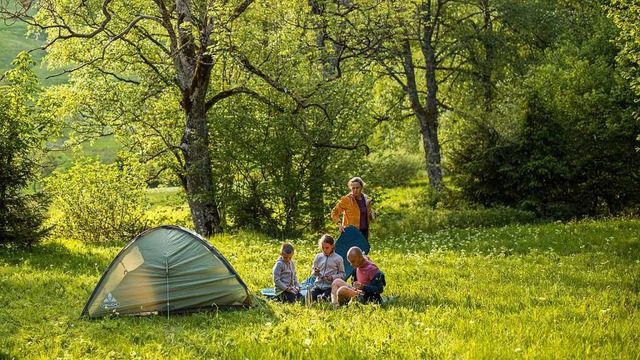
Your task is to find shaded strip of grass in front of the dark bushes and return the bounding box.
[372,221,640,261]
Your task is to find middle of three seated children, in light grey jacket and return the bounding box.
[311,234,345,301]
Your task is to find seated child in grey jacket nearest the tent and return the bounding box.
[273,243,302,303]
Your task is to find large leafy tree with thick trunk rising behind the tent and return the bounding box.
[3,0,306,235]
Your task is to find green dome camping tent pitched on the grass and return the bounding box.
[82,226,251,318]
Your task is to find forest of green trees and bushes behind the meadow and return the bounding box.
[2,0,640,244]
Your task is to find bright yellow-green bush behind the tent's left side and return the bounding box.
[46,159,147,243]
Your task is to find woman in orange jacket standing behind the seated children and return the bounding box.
[331,177,373,241]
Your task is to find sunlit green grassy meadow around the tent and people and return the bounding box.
[0,220,640,359]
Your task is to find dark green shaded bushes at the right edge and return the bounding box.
[452,89,640,219]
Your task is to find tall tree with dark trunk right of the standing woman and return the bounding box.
[324,0,516,190]
